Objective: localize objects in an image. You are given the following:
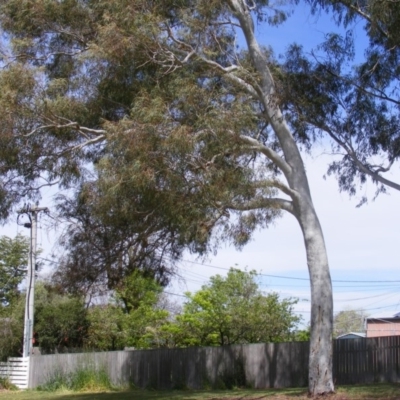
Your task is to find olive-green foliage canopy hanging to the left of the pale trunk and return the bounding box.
[0,0,286,288]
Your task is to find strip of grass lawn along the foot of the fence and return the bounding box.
[0,384,400,400]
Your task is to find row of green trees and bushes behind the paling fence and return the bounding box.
[0,236,300,359]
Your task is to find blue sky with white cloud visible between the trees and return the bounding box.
[0,2,400,326]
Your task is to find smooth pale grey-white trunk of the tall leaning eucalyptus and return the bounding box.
[228,0,334,395]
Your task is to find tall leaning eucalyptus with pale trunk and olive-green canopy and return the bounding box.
[0,0,334,394]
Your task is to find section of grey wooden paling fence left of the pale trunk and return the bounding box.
[29,342,308,389]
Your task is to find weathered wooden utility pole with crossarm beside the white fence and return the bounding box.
[18,205,48,357]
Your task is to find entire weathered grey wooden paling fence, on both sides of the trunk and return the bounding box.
[29,336,400,389]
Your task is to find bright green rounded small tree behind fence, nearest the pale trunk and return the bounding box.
[176,268,300,346]
